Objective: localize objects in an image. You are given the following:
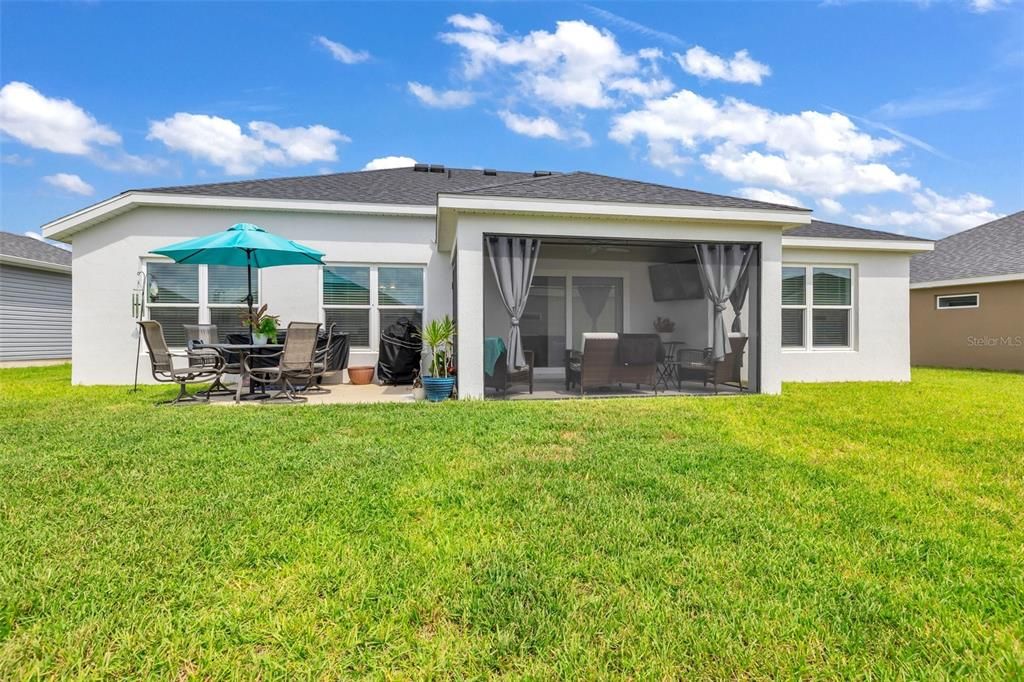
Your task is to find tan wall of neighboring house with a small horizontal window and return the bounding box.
[910,281,1024,371]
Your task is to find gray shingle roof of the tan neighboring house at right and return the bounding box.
[910,211,1024,283]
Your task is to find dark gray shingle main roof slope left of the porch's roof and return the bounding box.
[141,168,532,206]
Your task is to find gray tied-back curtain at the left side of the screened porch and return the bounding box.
[487,237,541,370]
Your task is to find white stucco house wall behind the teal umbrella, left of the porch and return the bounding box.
[72,208,452,384]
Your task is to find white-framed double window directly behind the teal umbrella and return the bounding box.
[145,260,259,348]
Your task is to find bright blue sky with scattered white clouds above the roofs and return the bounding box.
[0,0,1024,238]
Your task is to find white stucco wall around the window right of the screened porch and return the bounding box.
[764,248,910,381]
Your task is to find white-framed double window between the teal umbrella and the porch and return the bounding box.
[322,264,426,350]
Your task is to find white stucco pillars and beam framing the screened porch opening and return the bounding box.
[456,214,782,397]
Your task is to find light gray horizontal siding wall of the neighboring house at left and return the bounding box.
[0,264,72,361]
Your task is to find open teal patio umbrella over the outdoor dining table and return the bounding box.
[150,222,324,337]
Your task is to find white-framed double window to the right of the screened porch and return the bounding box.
[782,265,854,350]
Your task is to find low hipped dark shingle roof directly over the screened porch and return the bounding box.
[450,171,808,211]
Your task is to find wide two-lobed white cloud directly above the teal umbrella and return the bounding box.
[146,112,349,175]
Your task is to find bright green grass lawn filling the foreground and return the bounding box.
[0,367,1024,679]
